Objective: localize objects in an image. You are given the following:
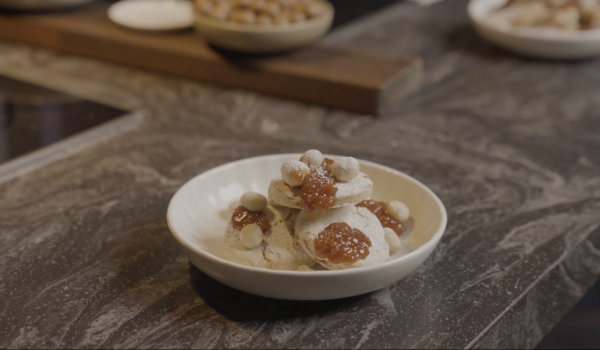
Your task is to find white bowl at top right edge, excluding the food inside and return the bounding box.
[468,0,600,59]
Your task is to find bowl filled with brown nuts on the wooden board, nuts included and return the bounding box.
[195,0,334,54]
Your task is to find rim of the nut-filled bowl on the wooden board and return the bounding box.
[194,0,335,33]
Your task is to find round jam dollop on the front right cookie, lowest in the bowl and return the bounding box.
[315,222,371,264]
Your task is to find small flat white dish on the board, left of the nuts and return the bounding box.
[108,0,194,31]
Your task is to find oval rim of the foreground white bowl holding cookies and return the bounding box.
[167,153,448,277]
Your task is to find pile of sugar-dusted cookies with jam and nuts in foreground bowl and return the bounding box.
[224,150,410,271]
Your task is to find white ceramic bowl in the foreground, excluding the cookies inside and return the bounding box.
[167,154,447,300]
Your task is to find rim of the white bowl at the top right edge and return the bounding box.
[467,0,600,43]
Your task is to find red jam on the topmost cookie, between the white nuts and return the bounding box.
[300,158,337,213]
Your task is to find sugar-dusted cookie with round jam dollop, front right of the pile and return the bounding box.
[296,206,389,270]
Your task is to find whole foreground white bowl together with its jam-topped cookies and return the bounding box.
[167,150,447,300]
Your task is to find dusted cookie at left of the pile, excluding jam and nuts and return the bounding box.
[223,205,315,271]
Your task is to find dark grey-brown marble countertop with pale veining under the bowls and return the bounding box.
[0,0,600,348]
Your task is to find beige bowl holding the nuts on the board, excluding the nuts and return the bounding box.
[195,1,334,53]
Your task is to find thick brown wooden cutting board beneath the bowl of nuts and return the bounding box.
[0,2,423,115]
